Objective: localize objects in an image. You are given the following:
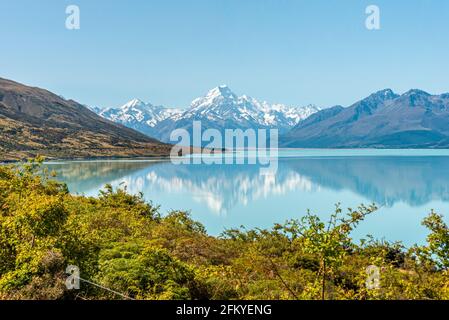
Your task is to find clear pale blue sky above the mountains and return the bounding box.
[0,0,449,107]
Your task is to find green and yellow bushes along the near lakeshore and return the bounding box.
[0,161,449,299]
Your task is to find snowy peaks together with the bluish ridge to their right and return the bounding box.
[99,85,449,148]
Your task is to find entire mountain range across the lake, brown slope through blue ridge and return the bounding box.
[0,78,449,161]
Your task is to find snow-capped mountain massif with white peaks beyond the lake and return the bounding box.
[99,85,320,142]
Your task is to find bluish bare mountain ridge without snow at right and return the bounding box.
[280,89,449,148]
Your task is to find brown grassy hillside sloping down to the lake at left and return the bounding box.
[0,78,171,161]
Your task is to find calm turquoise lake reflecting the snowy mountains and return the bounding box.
[46,149,449,246]
